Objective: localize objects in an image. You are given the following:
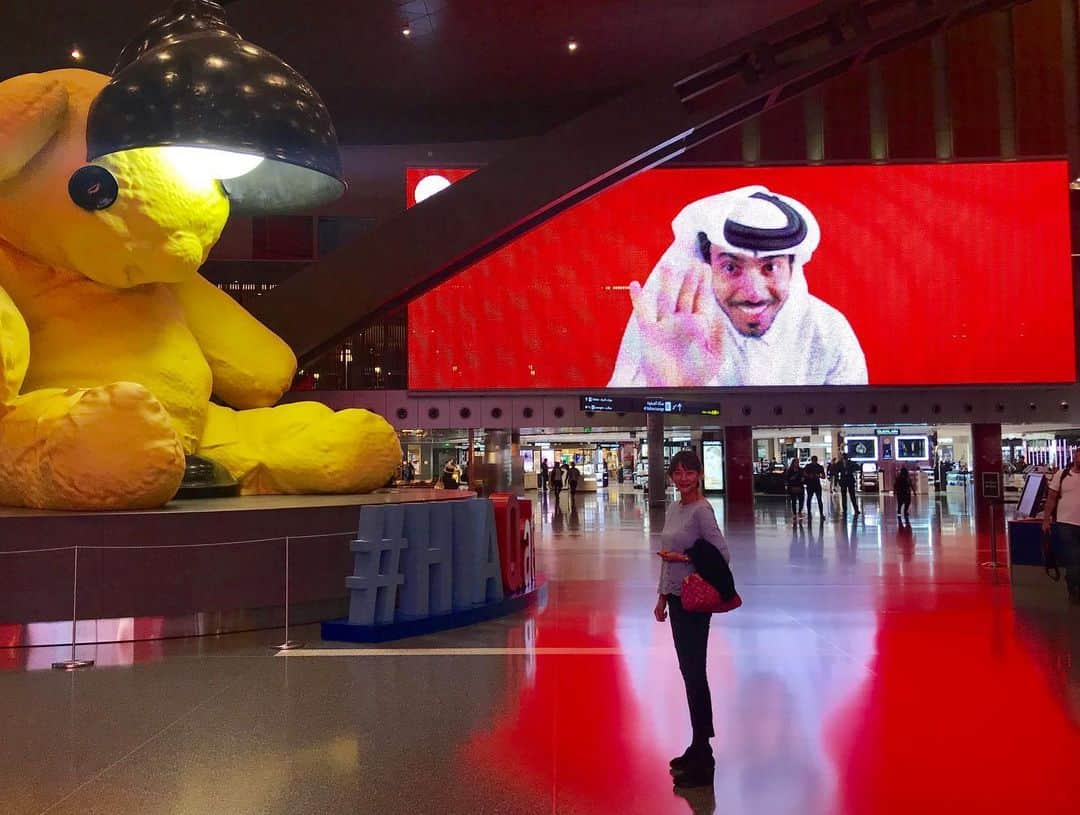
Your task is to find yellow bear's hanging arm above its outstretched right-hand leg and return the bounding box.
[168,274,296,410]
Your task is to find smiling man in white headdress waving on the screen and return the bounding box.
[608,187,867,388]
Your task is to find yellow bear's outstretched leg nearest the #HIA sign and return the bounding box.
[199,402,402,495]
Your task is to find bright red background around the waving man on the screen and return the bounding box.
[406,161,1076,390]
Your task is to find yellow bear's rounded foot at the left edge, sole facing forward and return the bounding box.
[0,382,184,510]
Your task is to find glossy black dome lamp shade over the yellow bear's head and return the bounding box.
[86,0,345,215]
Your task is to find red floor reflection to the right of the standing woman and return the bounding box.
[826,586,1080,814]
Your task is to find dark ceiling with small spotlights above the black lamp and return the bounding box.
[6,0,813,144]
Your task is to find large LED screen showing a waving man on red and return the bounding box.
[406,161,1076,390]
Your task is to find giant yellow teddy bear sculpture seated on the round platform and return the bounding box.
[0,70,401,510]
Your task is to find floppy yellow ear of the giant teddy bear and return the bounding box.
[0,73,68,181]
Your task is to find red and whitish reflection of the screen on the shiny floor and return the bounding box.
[463,578,1080,815]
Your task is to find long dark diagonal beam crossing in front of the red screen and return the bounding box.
[253,0,1023,361]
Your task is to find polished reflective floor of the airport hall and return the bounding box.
[0,490,1080,815]
